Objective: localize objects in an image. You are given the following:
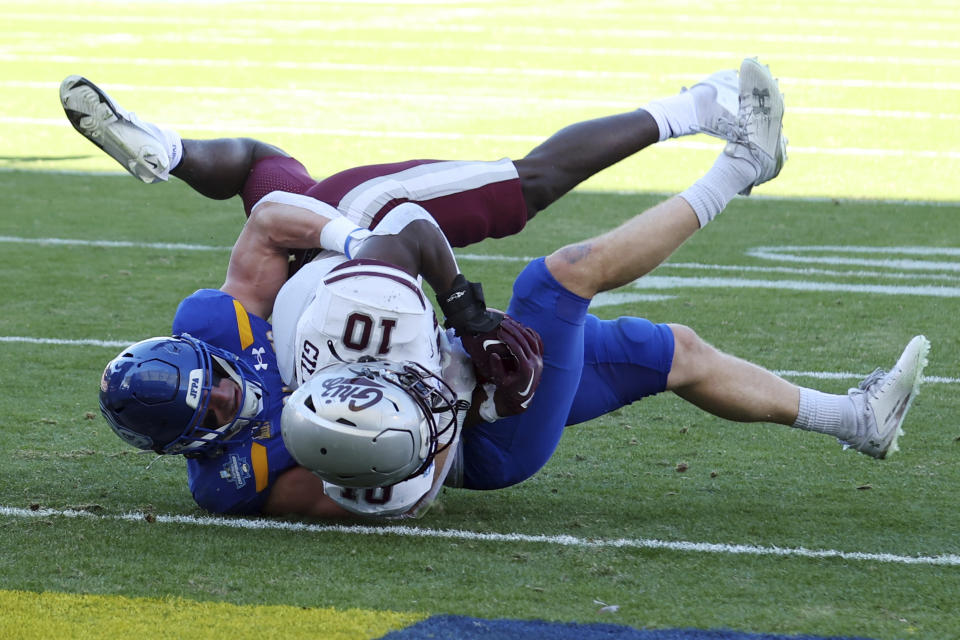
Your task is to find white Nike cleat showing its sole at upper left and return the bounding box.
[60,76,170,184]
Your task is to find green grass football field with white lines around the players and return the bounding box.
[0,0,960,639]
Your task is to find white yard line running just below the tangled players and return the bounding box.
[0,506,960,566]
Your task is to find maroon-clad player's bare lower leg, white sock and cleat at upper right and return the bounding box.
[515,70,739,218]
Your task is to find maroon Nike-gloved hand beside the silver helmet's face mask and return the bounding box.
[461,315,543,422]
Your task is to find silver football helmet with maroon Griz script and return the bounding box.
[281,359,463,488]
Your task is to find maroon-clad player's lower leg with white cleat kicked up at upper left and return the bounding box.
[60,76,285,199]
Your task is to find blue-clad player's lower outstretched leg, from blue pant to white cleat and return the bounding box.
[567,315,930,458]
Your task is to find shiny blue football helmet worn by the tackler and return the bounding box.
[100,334,266,456]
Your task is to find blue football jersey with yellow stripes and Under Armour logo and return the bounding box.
[173,289,297,513]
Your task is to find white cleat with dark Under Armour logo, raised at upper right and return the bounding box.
[724,58,787,195]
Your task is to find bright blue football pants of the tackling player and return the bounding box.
[461,258,674,489]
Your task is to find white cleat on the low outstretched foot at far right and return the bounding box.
[843,336,930,459]
